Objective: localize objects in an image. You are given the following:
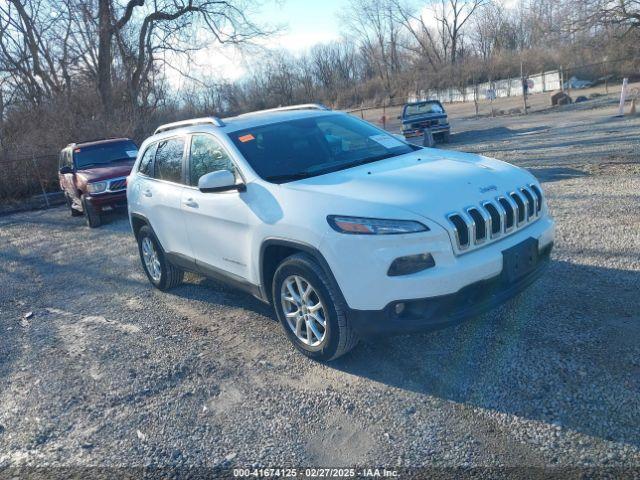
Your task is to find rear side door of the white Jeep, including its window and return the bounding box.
[139,136,193,259]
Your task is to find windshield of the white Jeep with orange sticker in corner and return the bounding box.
[230,114,418,183]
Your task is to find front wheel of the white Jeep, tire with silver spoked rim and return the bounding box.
[271,253,358,361]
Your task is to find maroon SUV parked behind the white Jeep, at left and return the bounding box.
[58,138,138,228]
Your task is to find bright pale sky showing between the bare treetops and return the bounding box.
[166,0,349,86]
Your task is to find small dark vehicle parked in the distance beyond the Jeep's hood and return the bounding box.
[399,100,451,143]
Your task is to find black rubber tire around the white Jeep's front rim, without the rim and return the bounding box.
[271,257,340,360]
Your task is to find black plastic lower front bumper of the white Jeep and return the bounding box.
[348,243,553,336]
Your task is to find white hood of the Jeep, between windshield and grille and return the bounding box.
[283,149,538,222]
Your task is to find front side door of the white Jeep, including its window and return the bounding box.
[182,133,250,280]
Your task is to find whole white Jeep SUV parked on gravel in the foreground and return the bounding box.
[127,105,554,360]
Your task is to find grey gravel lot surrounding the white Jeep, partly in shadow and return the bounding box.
[0,102,640,478]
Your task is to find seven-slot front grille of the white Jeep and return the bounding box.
[447,185,543,251]
